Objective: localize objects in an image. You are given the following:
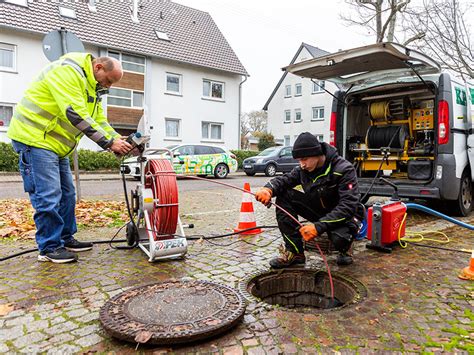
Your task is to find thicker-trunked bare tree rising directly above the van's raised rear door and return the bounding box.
[340,0,411,43]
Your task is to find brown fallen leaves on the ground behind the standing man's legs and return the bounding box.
[0,199,128,239]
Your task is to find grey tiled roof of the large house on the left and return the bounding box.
[0,0,248,75]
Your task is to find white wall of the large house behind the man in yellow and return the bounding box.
[0,29,242,149]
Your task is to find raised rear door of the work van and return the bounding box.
[283,43,441,85]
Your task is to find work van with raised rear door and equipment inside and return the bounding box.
[285,43,474,216]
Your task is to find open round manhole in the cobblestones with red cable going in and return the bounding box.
[241,269,367,309]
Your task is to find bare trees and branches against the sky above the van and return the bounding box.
[341,0,474,79]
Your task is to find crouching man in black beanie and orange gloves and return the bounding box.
[256,132,364,269]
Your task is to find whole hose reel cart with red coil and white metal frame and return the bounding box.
[120,135,193,262]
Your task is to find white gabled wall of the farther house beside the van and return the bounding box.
[267,47,337,145]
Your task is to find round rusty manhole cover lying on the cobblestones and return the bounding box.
[100,281,245,345]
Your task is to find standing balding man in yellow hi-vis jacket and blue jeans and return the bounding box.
[8,53,132,263]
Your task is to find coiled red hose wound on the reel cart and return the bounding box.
[145,159,179,240]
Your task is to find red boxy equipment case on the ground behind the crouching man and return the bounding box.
[366,178,407,253]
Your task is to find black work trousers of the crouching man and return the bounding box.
[275,189,358,253]
